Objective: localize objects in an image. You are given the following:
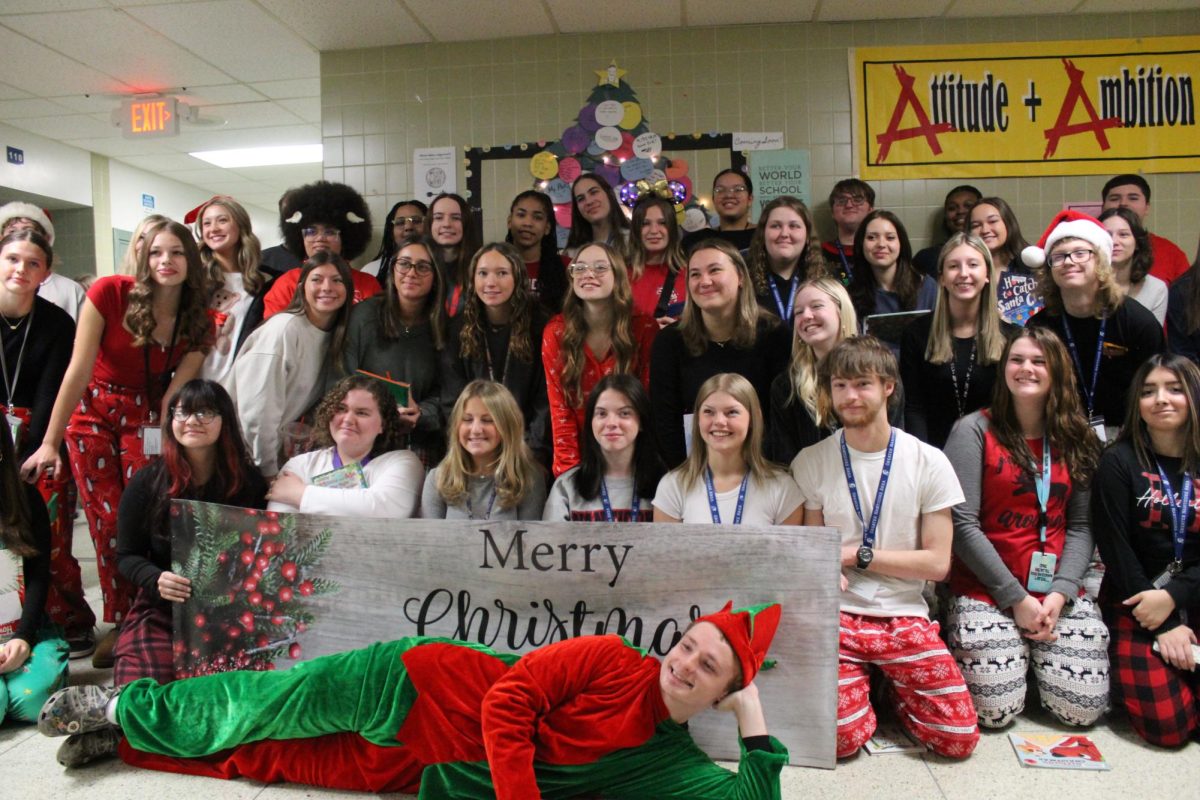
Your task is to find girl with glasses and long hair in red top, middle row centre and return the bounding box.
[541,243,659,476]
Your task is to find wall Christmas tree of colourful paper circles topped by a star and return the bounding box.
[529,60,708,246]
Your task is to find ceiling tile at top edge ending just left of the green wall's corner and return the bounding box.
[127,0,320,82]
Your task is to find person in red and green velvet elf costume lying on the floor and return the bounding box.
[38,603,787,800]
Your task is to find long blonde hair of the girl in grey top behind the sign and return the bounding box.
[437,380,542,509]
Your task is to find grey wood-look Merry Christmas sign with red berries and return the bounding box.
[172,501,840,768]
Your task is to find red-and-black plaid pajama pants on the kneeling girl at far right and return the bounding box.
[1104,607,1200,747]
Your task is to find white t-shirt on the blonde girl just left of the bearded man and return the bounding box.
[654,469,804,525]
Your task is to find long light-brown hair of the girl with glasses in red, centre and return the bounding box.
[559,242,638,407]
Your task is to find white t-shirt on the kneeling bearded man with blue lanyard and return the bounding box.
[792,428,962,619]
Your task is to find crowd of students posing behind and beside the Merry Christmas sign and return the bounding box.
[0,167,1200,786]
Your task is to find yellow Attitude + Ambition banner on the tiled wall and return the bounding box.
[850,36,1200,179]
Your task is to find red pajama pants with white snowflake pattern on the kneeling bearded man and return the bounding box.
[838,612,979,758]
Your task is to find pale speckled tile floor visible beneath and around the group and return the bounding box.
[0,515,1200,800]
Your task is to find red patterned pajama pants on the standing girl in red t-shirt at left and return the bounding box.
[66,381,150,622]
